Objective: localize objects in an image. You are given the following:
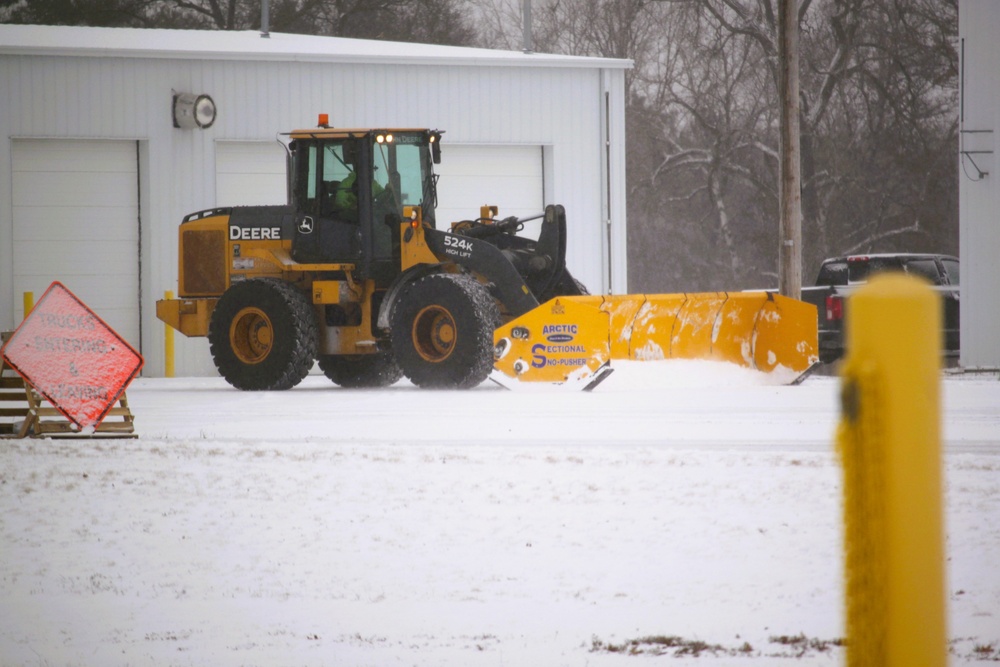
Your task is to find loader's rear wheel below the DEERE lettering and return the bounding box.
[208,278,319,391]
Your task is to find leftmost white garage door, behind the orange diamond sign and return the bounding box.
[12,139,140,349]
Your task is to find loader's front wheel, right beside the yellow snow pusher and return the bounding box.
[390,273,500,389]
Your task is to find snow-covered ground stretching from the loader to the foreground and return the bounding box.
[0,361,1000,667]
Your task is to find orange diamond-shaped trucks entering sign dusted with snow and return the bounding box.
[0,282,143,431]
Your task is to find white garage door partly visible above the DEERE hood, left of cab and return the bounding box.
[215,141,287,206]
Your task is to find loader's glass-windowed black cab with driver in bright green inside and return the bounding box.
[289,128,440,286]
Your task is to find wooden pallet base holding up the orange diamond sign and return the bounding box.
[0,332,139,438]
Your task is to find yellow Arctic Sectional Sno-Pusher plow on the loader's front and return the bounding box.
[494,292,819,388]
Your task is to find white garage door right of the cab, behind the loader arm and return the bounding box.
[434,142,544,238]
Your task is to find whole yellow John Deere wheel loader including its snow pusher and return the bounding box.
[156,115,816,390]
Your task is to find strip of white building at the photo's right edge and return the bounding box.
[958,0,1000,369]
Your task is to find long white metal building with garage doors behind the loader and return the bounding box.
[0,25,631,376]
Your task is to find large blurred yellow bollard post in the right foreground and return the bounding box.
[837,274,947,667]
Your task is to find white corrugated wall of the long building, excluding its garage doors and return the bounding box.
[0,31,626,375]
